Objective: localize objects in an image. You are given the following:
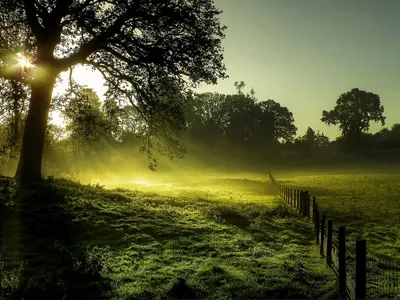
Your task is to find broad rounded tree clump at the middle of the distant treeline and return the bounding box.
[187,88,297,148]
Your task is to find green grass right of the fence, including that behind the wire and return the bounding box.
[275,170,400,299]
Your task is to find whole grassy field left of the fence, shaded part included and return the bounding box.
[0,177,337,300]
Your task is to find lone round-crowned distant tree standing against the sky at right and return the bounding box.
[321,88,385,142]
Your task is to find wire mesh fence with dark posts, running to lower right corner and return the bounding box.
[269,174,400,299]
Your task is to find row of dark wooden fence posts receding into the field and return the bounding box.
[269,174,400,299]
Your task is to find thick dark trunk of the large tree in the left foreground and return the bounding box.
[15,72,57,187]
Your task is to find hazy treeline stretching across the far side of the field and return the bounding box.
[0,77,400,176]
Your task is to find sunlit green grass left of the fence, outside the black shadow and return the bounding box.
[3,177,336,299]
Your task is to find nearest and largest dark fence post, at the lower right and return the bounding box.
[356,240,367,299]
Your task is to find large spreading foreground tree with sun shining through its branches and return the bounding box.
[0,0,226,185]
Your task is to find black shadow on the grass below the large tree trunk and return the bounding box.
[1,179,109,300]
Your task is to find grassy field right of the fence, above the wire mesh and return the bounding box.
[275,171,400,263]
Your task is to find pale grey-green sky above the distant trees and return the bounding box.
[53,0,400,138]
